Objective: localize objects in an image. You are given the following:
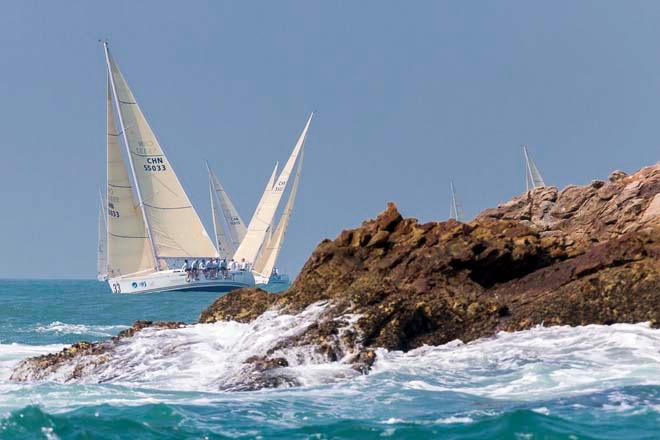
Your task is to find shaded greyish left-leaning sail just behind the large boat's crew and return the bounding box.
[206,162,248,253]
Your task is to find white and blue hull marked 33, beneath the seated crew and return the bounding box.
[108,270,255,294]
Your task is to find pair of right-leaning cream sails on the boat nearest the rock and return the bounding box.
[234,113,314,274]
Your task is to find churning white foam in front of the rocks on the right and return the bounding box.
[372,324,660,400]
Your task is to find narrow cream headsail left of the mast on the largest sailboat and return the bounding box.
[106,80,155,278]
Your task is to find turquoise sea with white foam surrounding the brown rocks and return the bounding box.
[0,281,660,439]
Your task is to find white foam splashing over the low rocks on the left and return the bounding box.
[36,303,358,392]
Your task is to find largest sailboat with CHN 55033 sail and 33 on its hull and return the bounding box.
[99,42,255,293]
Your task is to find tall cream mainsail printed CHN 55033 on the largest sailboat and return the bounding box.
[106,46,217,267]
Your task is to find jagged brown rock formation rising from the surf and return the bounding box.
[13,165,660,389]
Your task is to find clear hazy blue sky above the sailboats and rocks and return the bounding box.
[0,0,660,278]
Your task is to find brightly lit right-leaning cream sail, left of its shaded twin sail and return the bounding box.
[234,113,314,263]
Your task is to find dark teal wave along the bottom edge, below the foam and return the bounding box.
[0,402,657,440]
